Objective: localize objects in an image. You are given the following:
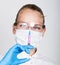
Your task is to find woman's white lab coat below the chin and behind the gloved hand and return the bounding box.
[17,52,55,65]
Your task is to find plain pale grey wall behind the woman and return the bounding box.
[0,0,60,65]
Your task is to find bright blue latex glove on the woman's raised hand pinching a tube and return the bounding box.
[0,44,33,65]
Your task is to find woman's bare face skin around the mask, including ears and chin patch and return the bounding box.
[13,9,45,56]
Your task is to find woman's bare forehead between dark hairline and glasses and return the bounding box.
[17,9,43,25]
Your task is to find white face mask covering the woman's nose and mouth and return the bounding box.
[15,29,42,48]
